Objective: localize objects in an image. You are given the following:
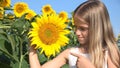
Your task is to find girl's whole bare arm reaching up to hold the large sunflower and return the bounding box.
[29,47,69,68]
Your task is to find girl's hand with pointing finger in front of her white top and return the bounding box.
[71,52,95,68]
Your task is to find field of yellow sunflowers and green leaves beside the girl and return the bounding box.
[0,0,79,68]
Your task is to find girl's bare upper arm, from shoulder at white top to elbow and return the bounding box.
[42,49,69,68]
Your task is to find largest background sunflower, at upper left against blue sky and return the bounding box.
[14,2,29,17]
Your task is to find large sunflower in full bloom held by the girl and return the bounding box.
[29,14,70,58]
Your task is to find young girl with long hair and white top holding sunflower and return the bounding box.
[29,0,120,68]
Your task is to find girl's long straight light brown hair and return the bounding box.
[73,0,120,68]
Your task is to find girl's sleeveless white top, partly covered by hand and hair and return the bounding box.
[69,48,108,68]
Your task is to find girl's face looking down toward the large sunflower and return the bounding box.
[74,22,89,45]
